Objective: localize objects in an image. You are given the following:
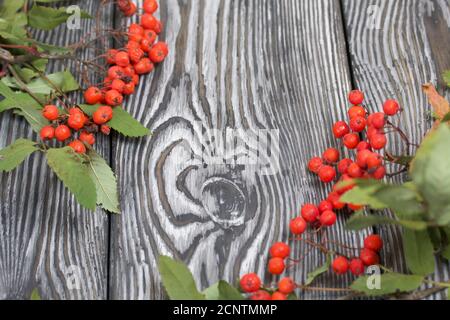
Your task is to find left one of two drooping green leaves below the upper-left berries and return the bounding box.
[47,147,96,210]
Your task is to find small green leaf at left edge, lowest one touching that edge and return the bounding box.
[0,139,39,172]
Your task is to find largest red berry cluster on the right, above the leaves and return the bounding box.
[306,90,401,218]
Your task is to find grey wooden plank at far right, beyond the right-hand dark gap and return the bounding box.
[343,0,450,300]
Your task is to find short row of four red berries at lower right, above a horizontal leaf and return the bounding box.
[332,235,383,276]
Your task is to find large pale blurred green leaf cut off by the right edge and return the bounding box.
[411,125,450,226]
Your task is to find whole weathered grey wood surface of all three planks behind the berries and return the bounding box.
[0,0,450,299]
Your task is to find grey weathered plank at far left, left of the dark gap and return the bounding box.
[0,1,112,299]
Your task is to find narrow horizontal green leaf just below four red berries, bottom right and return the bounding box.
[350,273,424,296]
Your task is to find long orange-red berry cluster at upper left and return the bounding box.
[40,0,169,153]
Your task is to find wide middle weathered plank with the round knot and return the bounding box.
[110,0,368,299]
